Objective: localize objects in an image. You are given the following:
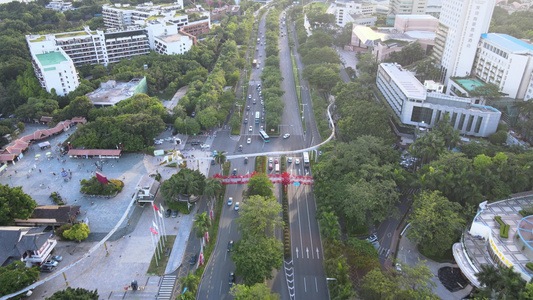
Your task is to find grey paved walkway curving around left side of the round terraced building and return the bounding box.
[394,230,472,300]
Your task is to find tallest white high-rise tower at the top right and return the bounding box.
[433,0,496,85]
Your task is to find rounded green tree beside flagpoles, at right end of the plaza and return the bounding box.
[161,168,205,202]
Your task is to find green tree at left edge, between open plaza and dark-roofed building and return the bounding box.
[0,184,37,225]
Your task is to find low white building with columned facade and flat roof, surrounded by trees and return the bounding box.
[376,63,501,137]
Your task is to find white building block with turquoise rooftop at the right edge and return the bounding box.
[474,33,533,99]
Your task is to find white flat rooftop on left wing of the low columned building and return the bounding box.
[380,63,426,100]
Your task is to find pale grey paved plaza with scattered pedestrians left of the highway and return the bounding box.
[0,125,214,299]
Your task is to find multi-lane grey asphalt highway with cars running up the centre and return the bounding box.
[197,5,329,299]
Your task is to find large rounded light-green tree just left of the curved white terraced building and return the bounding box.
[409,191,466,256]
